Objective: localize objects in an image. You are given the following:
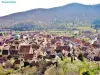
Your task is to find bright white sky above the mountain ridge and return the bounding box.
[0,0,100,16]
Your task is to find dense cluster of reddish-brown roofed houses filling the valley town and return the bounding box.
[0,32,100,69]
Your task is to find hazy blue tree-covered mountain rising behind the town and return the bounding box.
[0,3,100,28]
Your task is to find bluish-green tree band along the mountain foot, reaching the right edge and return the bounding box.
[3,20,100,31]
